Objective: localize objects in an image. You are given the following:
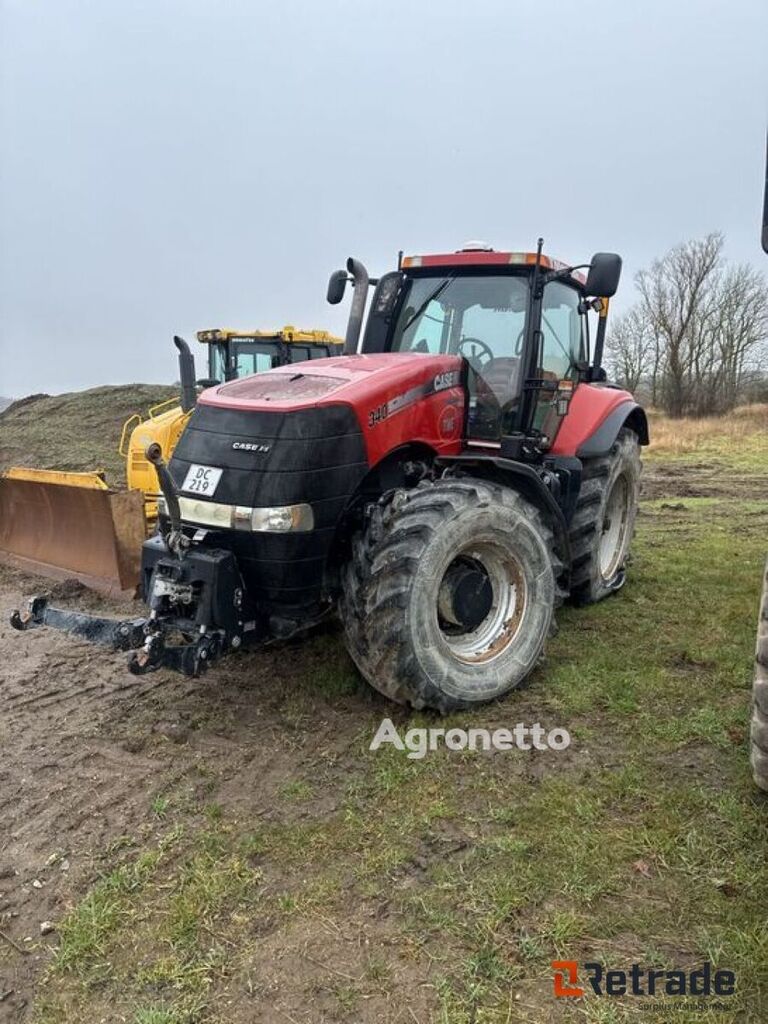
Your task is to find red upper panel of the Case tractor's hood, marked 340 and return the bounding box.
[199,352,464,465]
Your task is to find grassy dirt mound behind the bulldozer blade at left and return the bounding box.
[0,384,178,487]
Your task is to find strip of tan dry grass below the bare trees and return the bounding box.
[650,402,768,455]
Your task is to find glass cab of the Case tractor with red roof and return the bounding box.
[329,244,622,451]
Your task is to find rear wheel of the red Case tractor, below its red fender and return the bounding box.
[569,428,641,604]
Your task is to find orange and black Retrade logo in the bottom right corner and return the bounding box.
[552,961,736,997]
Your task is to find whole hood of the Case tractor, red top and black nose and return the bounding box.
[164,353,464,614]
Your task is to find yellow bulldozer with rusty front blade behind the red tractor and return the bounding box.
[0,325,344,593]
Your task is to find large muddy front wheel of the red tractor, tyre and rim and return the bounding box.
[340,478,560,714]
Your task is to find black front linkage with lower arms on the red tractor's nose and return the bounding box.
[10,445,263,677]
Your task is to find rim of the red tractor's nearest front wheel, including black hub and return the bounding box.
[436,541,527,665]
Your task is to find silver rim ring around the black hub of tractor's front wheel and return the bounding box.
[435,541,527,665]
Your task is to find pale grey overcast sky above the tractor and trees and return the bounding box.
[0,0,768,397]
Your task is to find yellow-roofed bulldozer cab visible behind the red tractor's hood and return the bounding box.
[198,325,344,383]
